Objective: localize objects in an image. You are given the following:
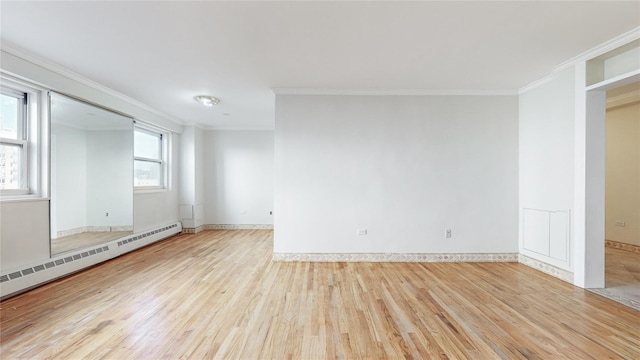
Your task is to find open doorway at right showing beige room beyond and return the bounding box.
[596,82,640,310]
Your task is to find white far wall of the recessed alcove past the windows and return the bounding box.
[203,130,273,224]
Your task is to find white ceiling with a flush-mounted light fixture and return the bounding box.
[0,0,640,129]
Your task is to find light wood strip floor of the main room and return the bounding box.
[0,230,640,359]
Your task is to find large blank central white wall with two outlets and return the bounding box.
[274,95,518,253]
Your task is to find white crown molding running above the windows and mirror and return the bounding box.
[1,42,184,125]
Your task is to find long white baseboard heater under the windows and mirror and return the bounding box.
[0,222,182,299]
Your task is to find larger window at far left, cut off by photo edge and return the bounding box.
[0,77,41,196]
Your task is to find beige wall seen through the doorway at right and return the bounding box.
[605,102,640,246]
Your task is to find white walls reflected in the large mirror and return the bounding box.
[51,128,133,232]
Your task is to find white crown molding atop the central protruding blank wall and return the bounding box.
[271,88,518,96]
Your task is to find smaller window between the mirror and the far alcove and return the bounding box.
[133,125,168,189]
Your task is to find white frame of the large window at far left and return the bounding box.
[0,74,48,200]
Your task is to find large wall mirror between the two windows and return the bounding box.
[50,93,133,256]
